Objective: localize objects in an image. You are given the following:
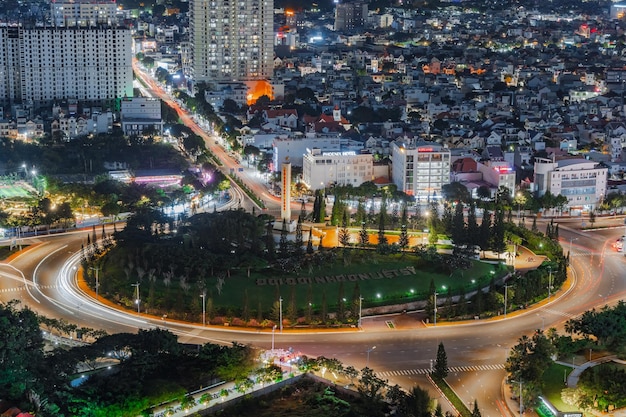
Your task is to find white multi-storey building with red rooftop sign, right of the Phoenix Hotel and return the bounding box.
[390,141,450,201]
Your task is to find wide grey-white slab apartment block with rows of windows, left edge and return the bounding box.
[0,26,133,105]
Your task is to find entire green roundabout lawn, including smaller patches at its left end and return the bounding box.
[97,250,507,320]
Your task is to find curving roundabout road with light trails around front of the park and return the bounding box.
[0,219,626,417]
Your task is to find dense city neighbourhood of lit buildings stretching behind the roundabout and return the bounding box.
[0,2,626,213]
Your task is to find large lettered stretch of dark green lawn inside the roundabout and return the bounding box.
[200,251,505,311]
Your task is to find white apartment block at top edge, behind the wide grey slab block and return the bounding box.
[50,0,117,26]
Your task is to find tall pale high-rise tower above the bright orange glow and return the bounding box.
[189,0,274,82]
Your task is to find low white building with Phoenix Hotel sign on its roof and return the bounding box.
[302,149,374,190]
